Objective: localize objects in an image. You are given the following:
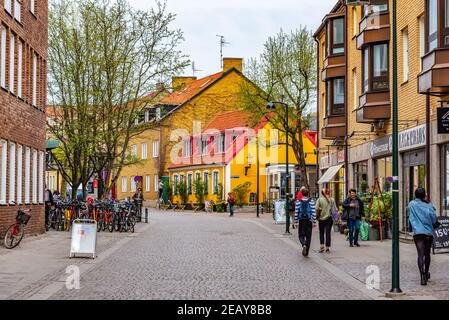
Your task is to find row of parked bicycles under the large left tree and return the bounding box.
[46,200,141,232]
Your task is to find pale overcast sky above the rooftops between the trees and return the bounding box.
[129,0,337,77]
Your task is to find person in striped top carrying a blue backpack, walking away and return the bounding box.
[294,189,316,257]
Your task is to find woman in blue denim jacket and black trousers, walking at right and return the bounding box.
[407,188,437,286]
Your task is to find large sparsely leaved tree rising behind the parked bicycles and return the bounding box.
[49,0,189,199]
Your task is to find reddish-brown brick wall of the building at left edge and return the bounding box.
[0,0,48,235]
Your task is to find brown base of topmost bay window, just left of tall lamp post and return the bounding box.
[357,12,390,50]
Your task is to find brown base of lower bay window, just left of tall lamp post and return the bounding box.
[356,91,391,123]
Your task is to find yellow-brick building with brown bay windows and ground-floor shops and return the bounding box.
[315,0,449,235]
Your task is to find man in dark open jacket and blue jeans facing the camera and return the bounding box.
[343,189,365,247]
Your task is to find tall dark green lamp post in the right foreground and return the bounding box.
[346,0,402,294]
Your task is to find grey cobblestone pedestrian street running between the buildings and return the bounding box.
[0,211,449,300]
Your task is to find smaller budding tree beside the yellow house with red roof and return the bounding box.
[239,27,317,188]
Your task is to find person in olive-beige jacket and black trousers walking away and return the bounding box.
[316,188,335,253]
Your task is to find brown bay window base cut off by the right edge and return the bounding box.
[418,48,449,97]
